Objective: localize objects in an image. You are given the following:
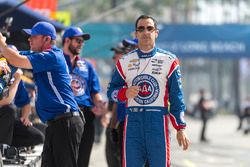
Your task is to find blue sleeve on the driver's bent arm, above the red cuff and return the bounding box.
[107,68,126,102]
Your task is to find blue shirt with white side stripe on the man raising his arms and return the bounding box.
[20,46,79,122]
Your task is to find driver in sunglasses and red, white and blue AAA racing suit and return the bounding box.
[107,15,190,167]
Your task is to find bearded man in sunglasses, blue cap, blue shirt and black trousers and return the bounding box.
[62,27,105,167]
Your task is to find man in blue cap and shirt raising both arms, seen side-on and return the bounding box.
[0,22,84,167]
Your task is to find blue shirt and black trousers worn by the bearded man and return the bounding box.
[64,54,101,166]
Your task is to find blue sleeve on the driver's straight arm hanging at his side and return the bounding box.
[168,66,186,130]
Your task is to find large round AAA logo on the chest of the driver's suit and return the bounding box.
[132,74,160,105]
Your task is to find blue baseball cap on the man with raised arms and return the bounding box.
[23,21,56,40]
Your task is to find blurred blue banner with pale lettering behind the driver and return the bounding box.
[157,25,250,58]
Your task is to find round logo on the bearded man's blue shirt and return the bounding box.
[71,74,86,96]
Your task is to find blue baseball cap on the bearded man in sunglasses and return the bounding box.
[63,27,90,40]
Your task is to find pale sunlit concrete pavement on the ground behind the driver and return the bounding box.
[90,115,250,167]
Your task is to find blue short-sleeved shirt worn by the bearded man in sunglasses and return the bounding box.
[64,54,101,107]
